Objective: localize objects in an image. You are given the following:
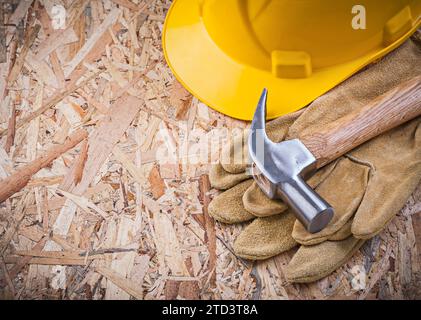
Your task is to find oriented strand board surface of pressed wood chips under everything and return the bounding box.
[0,0,421,299]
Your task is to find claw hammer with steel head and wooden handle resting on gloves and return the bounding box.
[248,76,421,233]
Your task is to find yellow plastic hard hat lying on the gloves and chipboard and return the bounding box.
[163,0,421,120]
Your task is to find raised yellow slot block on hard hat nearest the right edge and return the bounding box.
[383,6,412,46]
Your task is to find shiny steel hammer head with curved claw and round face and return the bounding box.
[248,89,334,233]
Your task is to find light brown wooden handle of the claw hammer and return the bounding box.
[300,76,421,168]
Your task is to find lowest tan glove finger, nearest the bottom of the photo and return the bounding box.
[285,236,364,283]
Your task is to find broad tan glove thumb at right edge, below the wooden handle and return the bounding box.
[351,117,421,239]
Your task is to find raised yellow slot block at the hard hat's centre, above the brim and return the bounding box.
[272,50,312,79]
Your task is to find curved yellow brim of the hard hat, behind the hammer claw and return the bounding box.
[162,0,420,120]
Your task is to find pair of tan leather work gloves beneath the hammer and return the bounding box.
[209,37,421,282]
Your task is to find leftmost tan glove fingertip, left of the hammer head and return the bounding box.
[208,179,255,224]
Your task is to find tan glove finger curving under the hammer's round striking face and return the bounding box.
[292,158,369,245]
